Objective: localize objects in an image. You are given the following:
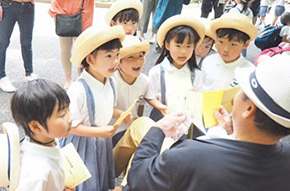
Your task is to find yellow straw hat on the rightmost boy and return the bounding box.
[211,13,259,41]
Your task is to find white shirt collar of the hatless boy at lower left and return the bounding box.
[21,137,60,160]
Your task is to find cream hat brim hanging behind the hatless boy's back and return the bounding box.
[3,122,20,191]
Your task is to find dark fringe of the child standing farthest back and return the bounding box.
[112,8,139,23]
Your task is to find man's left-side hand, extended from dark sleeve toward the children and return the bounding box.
[156,112,187,137]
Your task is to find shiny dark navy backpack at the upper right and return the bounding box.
[254,26,283,50]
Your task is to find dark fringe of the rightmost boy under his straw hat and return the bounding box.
[216,28,250,43]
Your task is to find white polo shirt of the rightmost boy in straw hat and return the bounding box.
[201,53,254,91]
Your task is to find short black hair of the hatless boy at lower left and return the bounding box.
[11,79,70,137]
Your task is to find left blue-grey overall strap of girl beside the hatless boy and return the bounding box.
[78,79,96,126]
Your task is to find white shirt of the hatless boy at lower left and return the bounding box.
[16,137,65,191]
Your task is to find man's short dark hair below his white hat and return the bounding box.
[243,93,290,137]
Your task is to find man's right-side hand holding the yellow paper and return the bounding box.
[214,105,233,135]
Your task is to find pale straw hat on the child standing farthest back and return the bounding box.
[105,0,143,26]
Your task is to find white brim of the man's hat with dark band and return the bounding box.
[235,68,290,128]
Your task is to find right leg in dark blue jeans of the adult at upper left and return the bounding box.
[18,3,34,76]
